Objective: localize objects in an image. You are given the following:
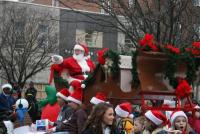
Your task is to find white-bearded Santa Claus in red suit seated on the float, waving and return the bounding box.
[49,44,95,92]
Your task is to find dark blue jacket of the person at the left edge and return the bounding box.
[0,93,15,111]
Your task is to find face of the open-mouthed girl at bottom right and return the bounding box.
[174,116,187,131]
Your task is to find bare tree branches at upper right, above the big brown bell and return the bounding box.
[59,0,200,47]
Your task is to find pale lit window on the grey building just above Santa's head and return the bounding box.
[76,30,103,48]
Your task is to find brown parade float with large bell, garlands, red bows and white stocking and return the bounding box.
[54,34,200,111]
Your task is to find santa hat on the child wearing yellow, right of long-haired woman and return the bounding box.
[115,102,133,118]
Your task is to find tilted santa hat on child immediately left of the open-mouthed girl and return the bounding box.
[144,110,167,126]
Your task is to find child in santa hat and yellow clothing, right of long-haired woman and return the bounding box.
[115,102,133,134]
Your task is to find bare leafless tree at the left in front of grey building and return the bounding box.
[0,5,58,87]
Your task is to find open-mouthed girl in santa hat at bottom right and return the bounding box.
[170,111,196,134]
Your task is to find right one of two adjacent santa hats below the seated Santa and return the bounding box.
[67,88,83,105]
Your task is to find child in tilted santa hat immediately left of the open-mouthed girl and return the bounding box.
[144,110,167,134]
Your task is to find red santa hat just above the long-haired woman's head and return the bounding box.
[90,92,106,105]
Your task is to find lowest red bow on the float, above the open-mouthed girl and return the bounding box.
[175,80,192,98]
